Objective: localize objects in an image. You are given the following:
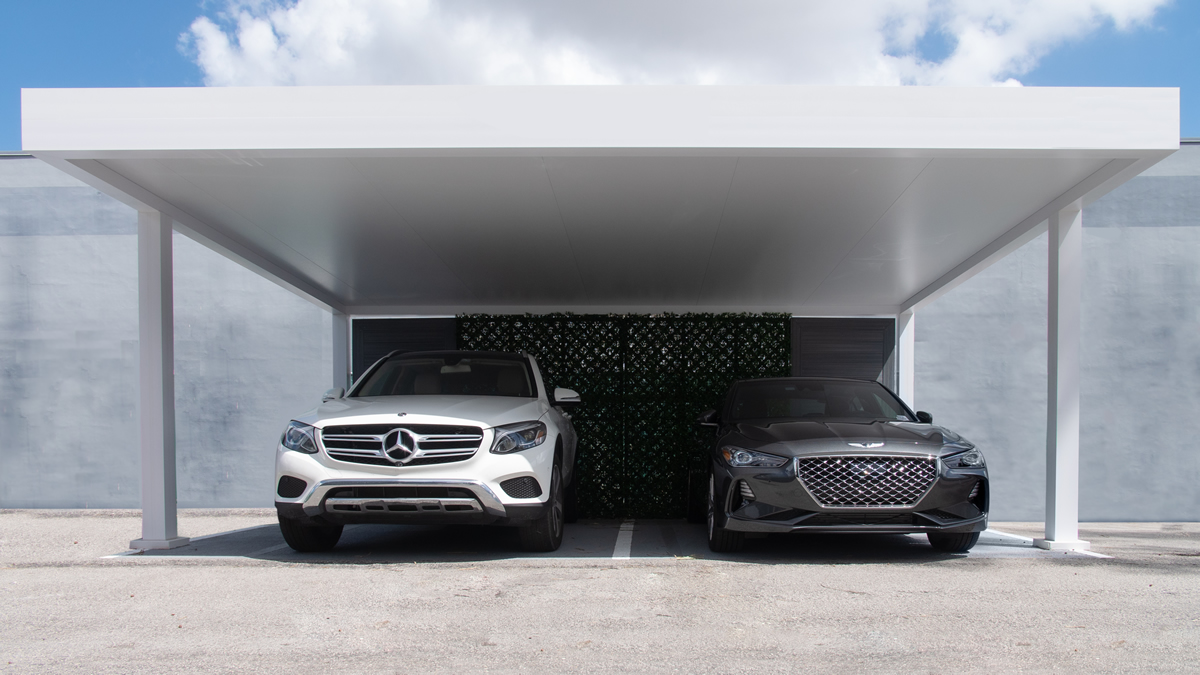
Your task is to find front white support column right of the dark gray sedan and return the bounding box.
[1034,203,1088,550]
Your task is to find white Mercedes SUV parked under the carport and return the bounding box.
[275,352,580,551]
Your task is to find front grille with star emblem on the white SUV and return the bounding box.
[320,424,484,466]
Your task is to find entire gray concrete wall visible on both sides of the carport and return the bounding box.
[0,145,1200,520]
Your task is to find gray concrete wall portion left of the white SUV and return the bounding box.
[0,159,331,507]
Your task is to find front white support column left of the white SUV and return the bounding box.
[130,211,188,549]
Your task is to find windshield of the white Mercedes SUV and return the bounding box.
[350,354,534,398]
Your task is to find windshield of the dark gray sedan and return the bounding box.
[728,380,914,422]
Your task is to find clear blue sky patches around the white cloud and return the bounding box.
[0,0,1200,151]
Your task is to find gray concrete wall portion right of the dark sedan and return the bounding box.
[916,145,1200,521]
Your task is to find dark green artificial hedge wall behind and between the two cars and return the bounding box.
[457,313,791,518]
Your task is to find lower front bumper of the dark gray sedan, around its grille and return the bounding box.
[713,460,990,533]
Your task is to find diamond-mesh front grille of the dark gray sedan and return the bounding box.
[797,455,937,507]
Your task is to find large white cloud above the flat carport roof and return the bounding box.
[181,0,1170,85]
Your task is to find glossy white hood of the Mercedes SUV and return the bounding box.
[298,396,548,428]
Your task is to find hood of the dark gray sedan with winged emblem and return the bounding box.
[725,419,964,456]
